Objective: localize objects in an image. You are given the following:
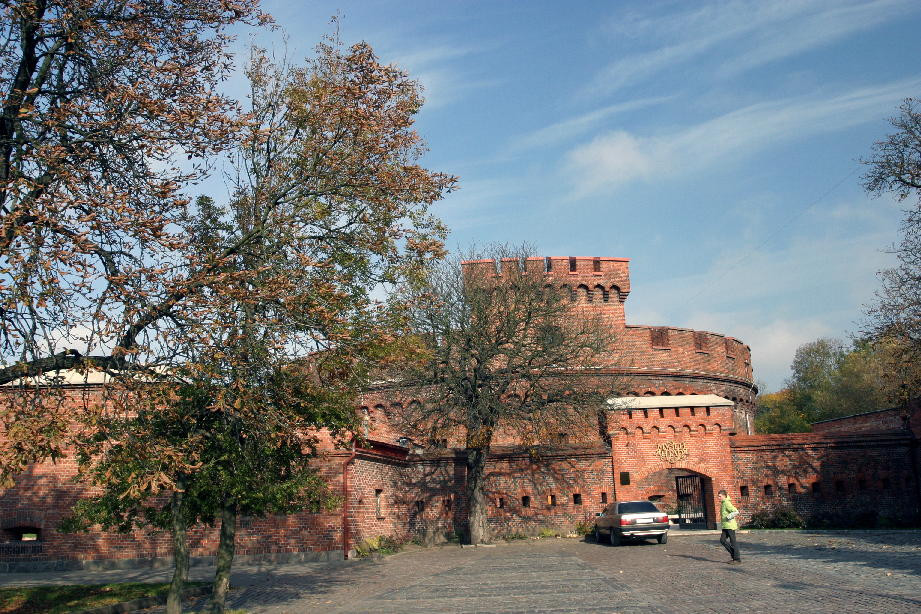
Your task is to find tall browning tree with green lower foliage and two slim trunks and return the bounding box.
[63,40,455,612]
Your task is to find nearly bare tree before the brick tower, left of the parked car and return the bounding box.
[403,246,609,544]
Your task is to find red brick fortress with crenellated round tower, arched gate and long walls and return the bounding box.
[0,258,921,563]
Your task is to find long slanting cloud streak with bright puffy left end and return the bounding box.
[564,78,921,196]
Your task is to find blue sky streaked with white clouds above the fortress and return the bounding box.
[221,0,921,390]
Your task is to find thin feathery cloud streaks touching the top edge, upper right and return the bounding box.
[585,0,919,95]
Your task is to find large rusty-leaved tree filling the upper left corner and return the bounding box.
[0,0,268,485]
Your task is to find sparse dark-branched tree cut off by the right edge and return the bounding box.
[863,98,921,406]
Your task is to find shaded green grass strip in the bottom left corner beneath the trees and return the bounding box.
[0,582,208,614]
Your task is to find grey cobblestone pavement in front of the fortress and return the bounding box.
[1,531,921,614]
